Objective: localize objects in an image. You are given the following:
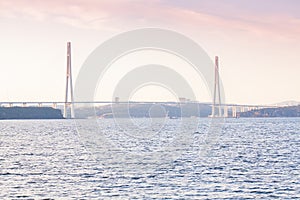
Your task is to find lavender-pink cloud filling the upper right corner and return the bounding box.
[159,0,300,40]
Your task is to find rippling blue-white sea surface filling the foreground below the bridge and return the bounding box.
[0,118,300,199]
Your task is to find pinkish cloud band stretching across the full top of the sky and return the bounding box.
[0,0,300,39]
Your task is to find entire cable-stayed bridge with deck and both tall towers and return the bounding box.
[0,42,278,118]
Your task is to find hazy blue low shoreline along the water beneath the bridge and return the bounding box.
[0,105,300,120]
